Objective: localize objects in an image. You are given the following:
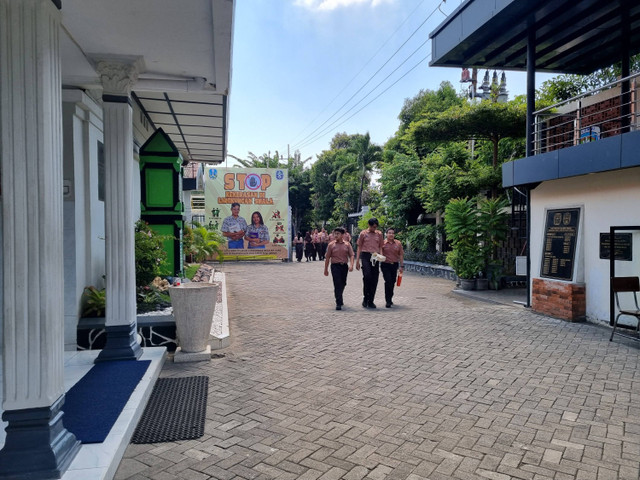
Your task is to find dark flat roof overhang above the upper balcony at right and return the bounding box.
[430,0,640,74]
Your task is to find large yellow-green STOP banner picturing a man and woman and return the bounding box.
[204,165,289,259]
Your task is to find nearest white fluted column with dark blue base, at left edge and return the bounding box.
[0,0,79,478]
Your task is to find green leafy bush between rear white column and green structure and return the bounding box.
[135,220,167,288]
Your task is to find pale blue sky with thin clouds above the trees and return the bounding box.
[227,0,549,166]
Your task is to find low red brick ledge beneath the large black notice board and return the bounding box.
[531,278,587,322]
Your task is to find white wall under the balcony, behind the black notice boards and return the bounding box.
[531,168,640,324]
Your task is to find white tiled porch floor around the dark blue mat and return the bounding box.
[0,347,166,480]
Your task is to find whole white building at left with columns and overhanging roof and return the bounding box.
[0,0,234,479]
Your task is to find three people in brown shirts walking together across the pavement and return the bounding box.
[324,218,404,310]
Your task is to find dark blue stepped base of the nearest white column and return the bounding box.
[0,395,81,480]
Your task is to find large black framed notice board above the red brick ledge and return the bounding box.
[540,208,580,280]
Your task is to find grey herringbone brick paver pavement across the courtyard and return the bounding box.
[116,262,640,480]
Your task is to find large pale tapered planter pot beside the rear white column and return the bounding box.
[169,282,220,353]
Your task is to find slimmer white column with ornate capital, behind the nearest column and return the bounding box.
[97,59,142,361]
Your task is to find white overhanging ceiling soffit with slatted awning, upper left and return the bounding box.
[60,0,234,162]
